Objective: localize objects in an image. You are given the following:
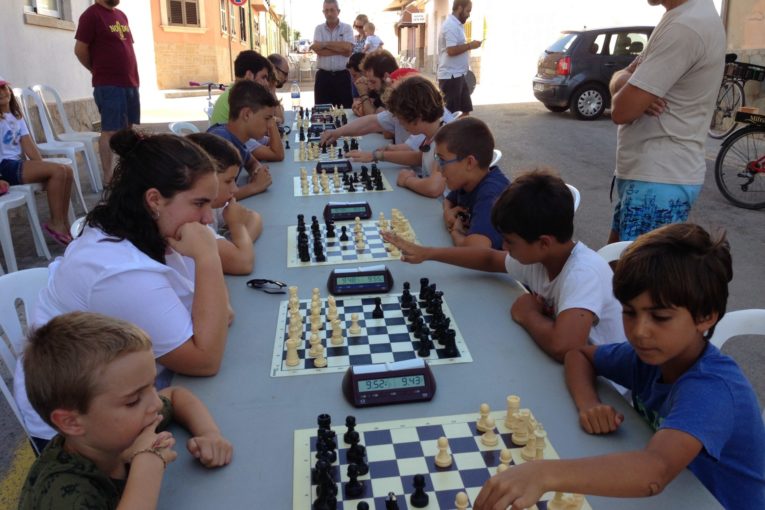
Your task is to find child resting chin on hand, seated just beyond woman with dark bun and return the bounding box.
[186,133,263,275]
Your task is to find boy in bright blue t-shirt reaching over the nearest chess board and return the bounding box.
[474,224,765,510]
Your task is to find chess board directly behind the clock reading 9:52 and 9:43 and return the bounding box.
[271,293,473,377]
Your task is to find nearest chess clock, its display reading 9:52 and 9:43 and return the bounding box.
[342,358,436,407]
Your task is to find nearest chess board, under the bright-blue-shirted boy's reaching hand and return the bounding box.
[292,411,592,510]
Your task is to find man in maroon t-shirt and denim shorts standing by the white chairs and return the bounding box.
[74,0,141,184]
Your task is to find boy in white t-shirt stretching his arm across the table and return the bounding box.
[383,171,626,362]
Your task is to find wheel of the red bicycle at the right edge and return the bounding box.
[715,126,765,209]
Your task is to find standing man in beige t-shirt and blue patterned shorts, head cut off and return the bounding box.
[608,0,725,243]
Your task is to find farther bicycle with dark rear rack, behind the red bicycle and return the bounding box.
[707,53,765,139]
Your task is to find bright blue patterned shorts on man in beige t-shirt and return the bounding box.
[611,177,701,241]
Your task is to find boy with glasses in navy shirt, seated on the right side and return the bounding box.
[434,117,510,250]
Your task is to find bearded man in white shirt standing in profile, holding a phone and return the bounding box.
[438,0,481,114]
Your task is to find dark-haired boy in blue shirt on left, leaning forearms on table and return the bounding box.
[207,80,279,200]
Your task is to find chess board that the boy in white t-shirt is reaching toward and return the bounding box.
[287,220,412,267]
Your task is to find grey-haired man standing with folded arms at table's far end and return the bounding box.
[311,0,355,108]
